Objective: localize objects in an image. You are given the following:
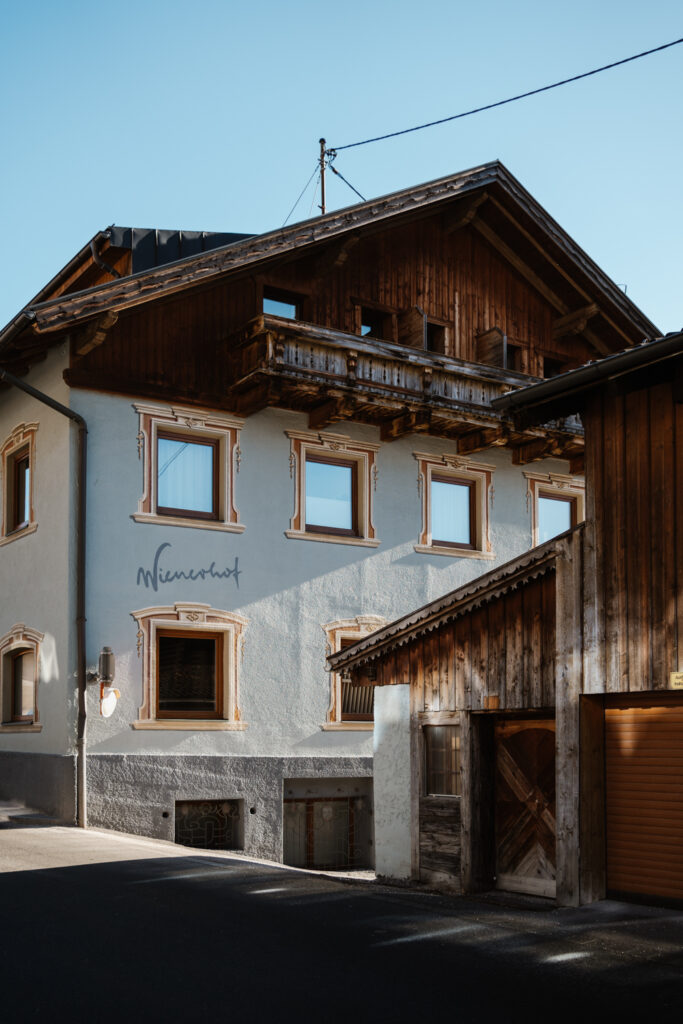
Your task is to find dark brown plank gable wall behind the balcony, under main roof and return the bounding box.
[69,218,588,395]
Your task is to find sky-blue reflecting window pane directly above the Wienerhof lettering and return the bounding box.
[157,437,215,514]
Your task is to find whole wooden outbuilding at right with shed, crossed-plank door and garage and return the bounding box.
[330,334,683,904]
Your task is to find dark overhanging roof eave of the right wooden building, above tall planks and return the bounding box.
[492,332,683,423]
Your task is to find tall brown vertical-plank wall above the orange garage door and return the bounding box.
[585,376,683,693]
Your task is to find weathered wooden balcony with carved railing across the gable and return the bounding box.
[225,314,584,471]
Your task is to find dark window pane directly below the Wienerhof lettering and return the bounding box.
[158,636,217,712]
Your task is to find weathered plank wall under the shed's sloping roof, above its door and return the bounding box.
[377,572,555,714]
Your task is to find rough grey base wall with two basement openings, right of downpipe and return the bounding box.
[88,754,374,868]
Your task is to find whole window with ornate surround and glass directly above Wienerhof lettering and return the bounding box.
[133,404,245,532]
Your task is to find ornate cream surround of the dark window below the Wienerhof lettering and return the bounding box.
[131,602,249,731]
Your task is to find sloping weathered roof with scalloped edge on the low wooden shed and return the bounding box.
[328,523,585,672]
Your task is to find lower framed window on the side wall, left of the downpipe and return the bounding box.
[0,623,44,732]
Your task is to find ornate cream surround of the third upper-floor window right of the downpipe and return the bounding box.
[413,452,496,559]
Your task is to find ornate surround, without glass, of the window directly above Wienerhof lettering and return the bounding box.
[131,402,245,534]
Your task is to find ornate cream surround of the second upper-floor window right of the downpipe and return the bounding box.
[285,430,380,548]
